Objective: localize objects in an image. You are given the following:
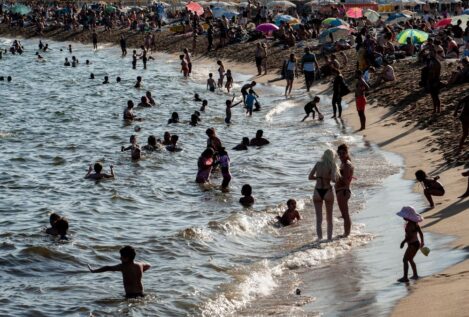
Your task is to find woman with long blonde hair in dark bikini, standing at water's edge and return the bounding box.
[308,150,340,240]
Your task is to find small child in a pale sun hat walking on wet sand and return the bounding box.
[397,206,424,283]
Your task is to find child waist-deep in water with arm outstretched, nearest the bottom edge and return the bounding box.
[88,246,151,298]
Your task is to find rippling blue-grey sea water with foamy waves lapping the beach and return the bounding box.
[0,39,462,316]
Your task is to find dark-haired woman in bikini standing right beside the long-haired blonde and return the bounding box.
[335,144,353,237]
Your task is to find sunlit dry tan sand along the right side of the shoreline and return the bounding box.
[343,102,469,317]
